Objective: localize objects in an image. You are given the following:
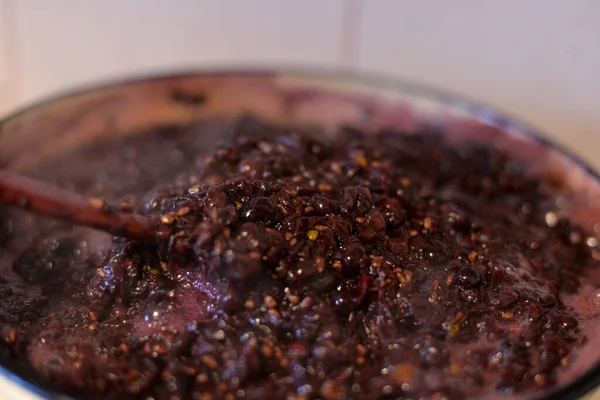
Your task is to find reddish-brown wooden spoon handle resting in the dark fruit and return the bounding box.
[0,170,154,241]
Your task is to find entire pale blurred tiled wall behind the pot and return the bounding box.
[0,0,600,165]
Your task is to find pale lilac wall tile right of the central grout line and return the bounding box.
[359,0,600,167]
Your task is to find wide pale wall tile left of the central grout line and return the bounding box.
[0,0,353,110]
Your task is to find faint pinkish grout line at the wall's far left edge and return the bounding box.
[0,0,22,112]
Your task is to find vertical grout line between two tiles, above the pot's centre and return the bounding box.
[338,0,365,70]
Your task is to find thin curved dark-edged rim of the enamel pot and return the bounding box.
[0,66,600,400]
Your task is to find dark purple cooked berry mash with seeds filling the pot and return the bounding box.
[0,119,598,400]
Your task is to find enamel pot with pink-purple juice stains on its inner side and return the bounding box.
[0,70,600,400]
